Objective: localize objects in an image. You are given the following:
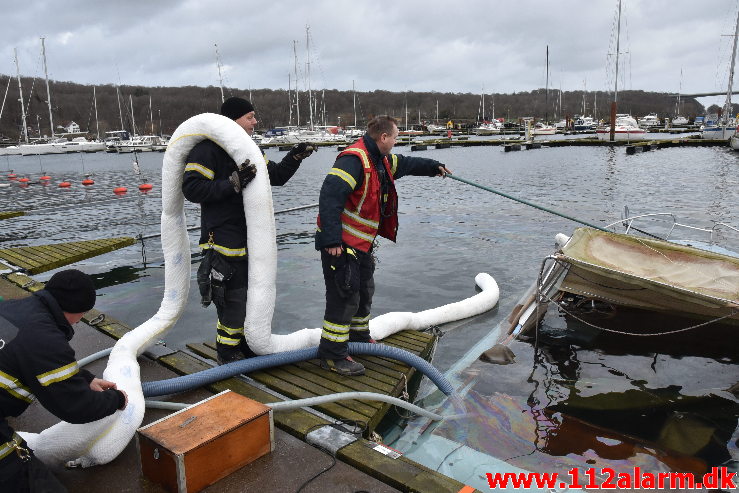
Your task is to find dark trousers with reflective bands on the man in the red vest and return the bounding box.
[318,249,375,359]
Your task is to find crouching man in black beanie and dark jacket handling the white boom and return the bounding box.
[0,269,127,493]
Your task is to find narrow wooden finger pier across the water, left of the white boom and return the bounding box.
[0,236,136,274]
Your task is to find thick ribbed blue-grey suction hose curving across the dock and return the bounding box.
[141,342,454,397]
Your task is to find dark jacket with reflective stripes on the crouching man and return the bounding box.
[0,290,125,443]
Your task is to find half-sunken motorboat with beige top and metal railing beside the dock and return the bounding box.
[501,212,739,344]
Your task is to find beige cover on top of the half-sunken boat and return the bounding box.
[557,228,739,322]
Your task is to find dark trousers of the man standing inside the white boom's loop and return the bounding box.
[212,258,255,359]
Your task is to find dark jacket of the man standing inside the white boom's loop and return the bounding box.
[182,140,300,259]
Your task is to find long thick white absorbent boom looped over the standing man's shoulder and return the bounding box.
[20,113,500,467]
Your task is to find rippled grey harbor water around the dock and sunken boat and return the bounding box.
[0,136,739,484]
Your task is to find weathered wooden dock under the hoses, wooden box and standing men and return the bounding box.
[0,273,476,493]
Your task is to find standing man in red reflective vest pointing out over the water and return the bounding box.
[316,116,450,375]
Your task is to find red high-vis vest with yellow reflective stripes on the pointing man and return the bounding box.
[317,138,398,252]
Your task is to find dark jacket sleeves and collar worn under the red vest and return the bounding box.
[316,134,442,250]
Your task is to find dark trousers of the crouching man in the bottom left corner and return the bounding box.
[0,434,67,493]
